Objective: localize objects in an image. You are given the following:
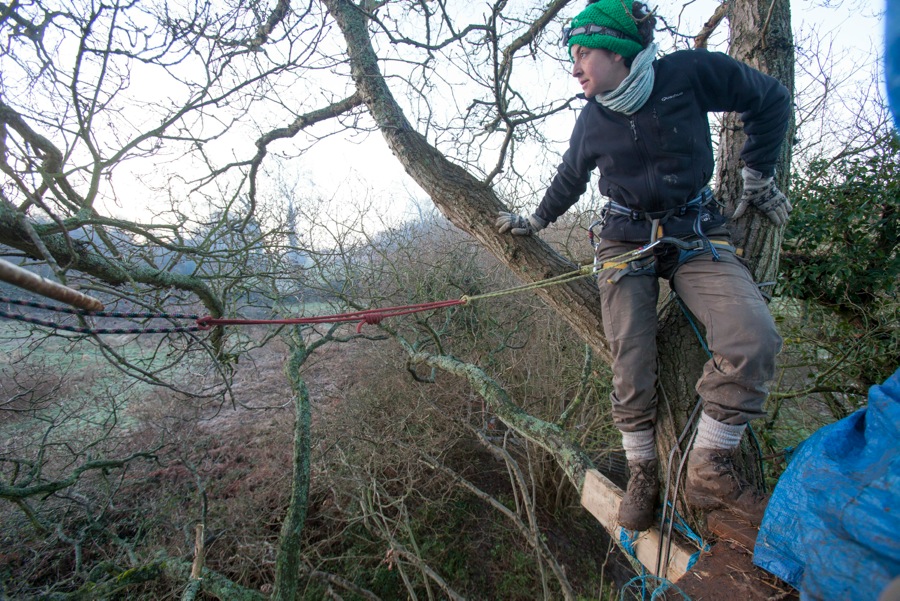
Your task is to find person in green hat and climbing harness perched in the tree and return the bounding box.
[497,0,791,530]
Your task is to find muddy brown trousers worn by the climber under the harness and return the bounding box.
[597,236,781,432]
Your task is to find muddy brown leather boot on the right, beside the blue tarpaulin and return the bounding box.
[684,449,769,526]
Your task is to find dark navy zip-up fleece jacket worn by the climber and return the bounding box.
[535,50,790,242]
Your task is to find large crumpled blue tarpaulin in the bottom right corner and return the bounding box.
[753,369,900,601]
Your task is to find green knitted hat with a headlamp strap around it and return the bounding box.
[565,0,644,58]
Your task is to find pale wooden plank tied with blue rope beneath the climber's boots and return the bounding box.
[581,470,696,582]
